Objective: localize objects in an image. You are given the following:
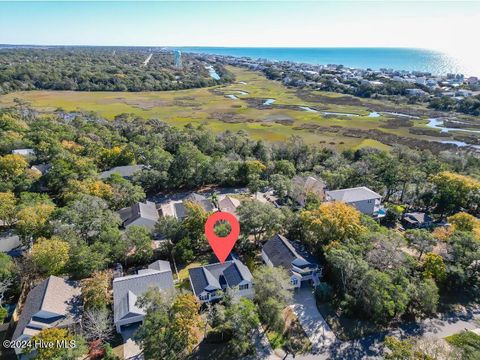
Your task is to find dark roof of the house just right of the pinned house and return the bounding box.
[262,234,317,270]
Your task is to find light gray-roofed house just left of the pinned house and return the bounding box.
[113,260,173,333]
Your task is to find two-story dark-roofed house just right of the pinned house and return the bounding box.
[262,234,321,288]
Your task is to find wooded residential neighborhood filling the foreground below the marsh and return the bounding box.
[0,88,480,360]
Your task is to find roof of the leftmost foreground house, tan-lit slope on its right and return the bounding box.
[12,276,80,339]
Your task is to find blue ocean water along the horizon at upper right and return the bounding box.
[175,47,472,75]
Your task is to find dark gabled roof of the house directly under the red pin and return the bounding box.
[188,259,253,295]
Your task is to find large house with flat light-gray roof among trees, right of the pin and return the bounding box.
[325,186,386,218]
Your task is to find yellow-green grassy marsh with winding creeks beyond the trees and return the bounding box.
[0,68,462,149]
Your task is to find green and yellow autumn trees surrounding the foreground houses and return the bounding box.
[0,103,480,358]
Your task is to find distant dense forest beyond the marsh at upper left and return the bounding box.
[0,47,231,94]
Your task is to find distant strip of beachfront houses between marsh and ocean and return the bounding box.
[202,54,480,101]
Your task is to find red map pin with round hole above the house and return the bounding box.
[205,211,240,264]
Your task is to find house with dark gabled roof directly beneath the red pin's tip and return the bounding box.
[188,258,255,303]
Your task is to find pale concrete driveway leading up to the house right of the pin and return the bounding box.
[290,287,337,353]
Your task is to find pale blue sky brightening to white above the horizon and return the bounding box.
[0,1,480,52]
